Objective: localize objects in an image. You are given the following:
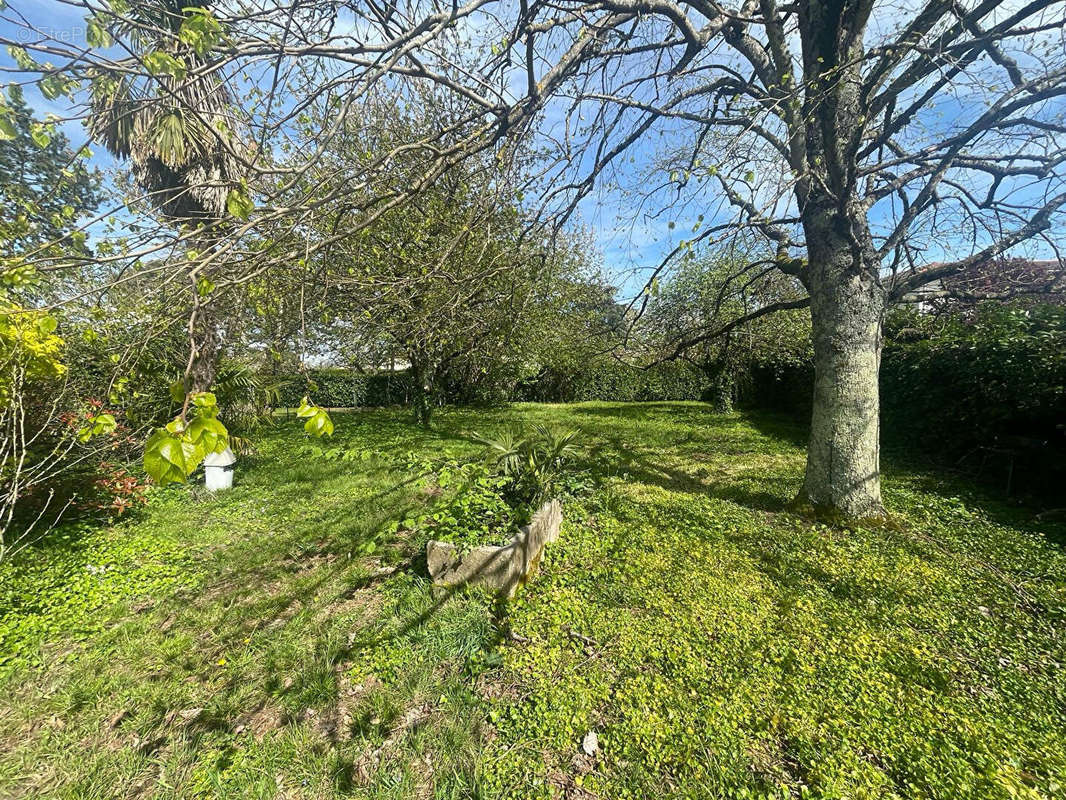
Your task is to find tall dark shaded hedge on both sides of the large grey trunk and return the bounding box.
[743,304,1066,497]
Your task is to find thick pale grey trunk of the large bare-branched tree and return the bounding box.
[800,235,885,518]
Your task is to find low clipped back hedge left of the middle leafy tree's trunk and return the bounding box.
[279,369,411,409]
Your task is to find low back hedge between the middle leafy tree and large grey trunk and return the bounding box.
[514,362,710,403]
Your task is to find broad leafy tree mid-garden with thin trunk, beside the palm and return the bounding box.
[247,92,609,425]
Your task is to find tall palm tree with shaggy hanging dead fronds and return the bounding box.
[88,0,243,391]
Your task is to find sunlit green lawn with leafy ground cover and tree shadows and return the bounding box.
[0,403,1066,799]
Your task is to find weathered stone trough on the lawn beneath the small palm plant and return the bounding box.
[425,500,563,597]
